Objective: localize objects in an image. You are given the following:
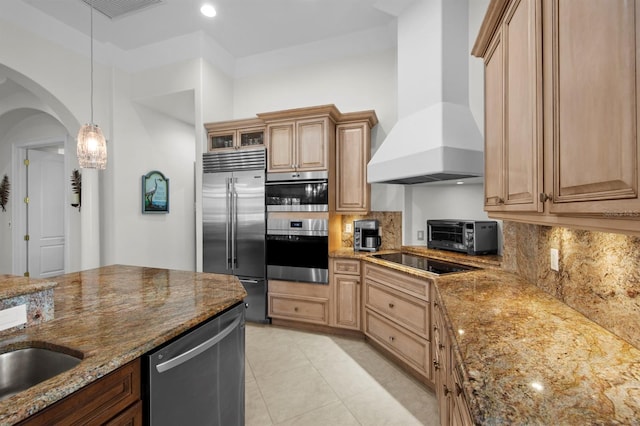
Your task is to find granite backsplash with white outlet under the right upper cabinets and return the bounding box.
[503,221,640,348]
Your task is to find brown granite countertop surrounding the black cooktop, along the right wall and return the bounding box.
[332,246,640,425]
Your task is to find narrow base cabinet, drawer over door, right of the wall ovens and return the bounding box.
[329,258,362,330]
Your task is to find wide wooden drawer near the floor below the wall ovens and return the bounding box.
[269,293,329,324]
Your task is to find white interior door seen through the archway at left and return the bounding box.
[27,149,65,278]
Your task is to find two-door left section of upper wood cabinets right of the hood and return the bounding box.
[485,0,542,212]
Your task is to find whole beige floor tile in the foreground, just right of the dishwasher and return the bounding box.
[256,364,338,423]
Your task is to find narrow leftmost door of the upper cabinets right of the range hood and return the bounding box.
[484,30,504,211]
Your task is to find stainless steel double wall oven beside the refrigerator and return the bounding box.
[265,172,329,284]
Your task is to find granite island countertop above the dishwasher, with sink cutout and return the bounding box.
[0,265,246,425]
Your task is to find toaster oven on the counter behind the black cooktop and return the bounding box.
[427,219,498,255]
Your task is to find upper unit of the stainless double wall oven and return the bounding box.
[265,172,329,212]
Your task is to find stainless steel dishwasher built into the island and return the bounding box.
[144,303,245,426]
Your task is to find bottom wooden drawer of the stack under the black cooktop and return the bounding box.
[365,309,431,379]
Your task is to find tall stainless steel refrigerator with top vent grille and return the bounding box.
[202,149,268,322]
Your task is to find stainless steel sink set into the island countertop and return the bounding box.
[0,347,82,401]
